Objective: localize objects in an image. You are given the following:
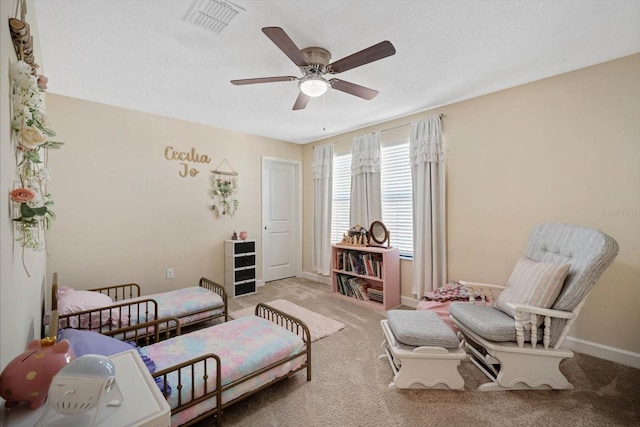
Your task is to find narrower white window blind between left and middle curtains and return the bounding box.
[331,153,351,243]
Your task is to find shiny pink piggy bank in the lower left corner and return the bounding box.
[0,338,73,409]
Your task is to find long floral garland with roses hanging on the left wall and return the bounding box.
[9,60,63,275]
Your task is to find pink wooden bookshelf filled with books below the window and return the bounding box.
[331,245,400,310]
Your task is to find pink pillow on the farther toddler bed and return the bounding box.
[58,288,113,329]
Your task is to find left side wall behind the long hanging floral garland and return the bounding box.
[0,0,46,372]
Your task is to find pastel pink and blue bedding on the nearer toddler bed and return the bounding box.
[140,315,305,425]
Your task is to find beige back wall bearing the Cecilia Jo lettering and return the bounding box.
[48,95,302,294]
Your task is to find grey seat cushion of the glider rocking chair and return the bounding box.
[449,302,542,342]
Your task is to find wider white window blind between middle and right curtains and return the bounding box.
[380,141,413,257]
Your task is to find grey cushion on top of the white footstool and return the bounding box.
[387,310,460,348]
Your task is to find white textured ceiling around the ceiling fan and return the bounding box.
[32,0,640,143]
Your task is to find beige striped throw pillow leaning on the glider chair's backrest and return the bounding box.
[494,257,570,328]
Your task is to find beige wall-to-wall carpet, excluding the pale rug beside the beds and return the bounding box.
[199,278,640,427]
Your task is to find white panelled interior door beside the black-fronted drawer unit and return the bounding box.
[262,158,302,282]
